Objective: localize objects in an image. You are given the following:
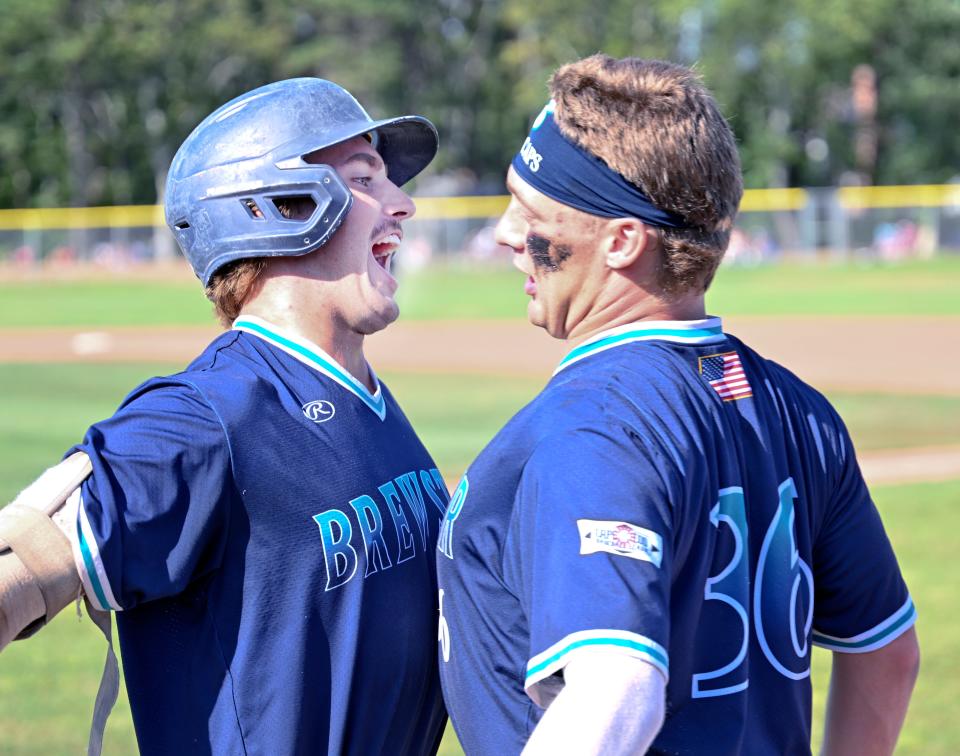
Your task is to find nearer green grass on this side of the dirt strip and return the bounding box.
[0,364,960,756]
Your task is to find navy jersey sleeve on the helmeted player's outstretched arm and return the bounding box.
[71,384,233,610]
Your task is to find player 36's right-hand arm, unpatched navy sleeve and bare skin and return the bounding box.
[813,413,920,756]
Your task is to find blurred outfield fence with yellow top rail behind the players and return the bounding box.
[0,184,960,264]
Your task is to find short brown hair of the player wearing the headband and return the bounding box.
[550,54,743,294]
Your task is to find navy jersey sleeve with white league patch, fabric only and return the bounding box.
[504,427,671,706]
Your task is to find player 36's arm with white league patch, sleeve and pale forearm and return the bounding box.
[505,424,676,754]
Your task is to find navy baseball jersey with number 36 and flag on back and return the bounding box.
[437,318,915,755]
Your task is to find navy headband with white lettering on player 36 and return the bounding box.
[513,100,689,228]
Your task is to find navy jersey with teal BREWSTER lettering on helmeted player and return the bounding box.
[65,318,447,756]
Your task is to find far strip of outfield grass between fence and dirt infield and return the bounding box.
[0,256,960,328]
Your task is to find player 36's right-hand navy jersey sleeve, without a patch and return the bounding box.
[813,418,916,653]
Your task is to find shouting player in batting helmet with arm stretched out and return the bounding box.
[0,79,447,754]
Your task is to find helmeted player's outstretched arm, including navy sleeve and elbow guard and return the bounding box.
[0,382,232,648]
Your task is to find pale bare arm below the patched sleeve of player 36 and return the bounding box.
[523,649,666,756]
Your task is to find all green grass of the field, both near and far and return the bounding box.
[0,258,960,756]
